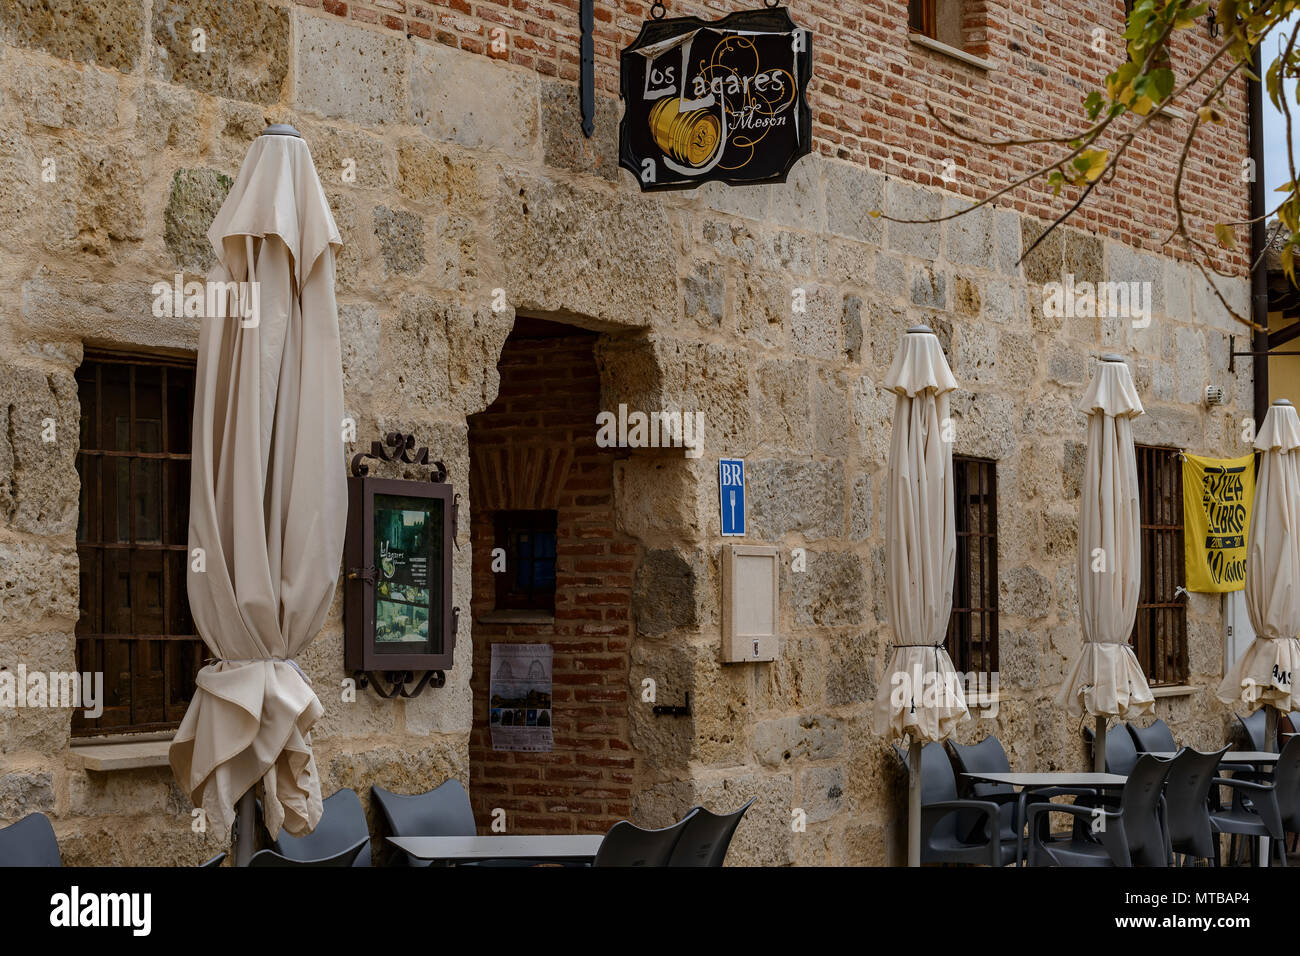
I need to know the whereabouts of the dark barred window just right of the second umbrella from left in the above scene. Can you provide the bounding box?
[945,455,998,674]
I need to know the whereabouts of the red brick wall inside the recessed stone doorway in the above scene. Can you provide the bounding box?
[469,325,637,832]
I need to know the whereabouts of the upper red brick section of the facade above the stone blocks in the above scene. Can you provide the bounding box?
[294,0,1248,273]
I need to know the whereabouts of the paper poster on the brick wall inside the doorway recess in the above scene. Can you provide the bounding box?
[488,644,555,752]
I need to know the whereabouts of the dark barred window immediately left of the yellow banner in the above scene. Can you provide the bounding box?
[1130,445,1188,687]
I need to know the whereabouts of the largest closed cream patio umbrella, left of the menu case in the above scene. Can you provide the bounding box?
[170,126,347,865]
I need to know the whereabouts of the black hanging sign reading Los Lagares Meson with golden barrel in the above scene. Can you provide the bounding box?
[619,7,813,190]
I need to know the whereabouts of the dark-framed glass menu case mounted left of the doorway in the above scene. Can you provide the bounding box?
[343,476,456,672]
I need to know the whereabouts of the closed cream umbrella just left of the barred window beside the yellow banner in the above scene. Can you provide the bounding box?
[1057,355,1156,773]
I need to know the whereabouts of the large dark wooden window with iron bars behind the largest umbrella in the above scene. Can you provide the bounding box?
[73,352,204,736]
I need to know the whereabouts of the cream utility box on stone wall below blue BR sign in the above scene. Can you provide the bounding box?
[723,545,781,663]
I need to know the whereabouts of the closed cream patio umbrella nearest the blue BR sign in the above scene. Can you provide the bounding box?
[875,325,969,866]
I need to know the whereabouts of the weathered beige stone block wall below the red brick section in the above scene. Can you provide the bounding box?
[0,0,1251,864]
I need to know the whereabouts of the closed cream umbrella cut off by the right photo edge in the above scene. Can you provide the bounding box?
[1218,398,1300,749]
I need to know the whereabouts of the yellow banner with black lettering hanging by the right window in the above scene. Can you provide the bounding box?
[1183,455,1255,592]
